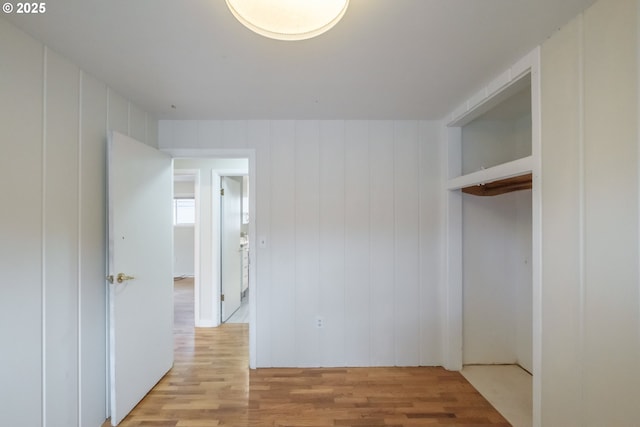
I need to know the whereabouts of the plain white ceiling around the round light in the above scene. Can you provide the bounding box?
[5,0,593,119]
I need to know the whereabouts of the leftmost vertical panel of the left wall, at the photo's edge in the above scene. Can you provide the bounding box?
[0,19,43,427]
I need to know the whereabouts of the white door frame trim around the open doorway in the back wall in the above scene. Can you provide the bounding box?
[160,148,259,369]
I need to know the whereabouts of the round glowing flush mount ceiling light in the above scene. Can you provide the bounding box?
[226,0,349,40]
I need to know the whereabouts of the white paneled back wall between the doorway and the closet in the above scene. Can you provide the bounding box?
[159,120,443,367]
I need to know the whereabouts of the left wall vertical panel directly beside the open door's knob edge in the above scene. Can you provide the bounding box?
[80,74,107,426]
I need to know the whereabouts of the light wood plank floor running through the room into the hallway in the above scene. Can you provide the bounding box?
[105,281,509,427]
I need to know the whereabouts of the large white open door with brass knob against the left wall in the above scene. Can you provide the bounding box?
[108,132,173,426]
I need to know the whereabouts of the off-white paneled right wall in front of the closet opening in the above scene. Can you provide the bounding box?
[541,0,640,426]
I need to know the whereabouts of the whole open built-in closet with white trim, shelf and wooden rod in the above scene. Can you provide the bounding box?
[446,52,540,421]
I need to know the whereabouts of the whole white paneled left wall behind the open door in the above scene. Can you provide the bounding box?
[0,19,157,427]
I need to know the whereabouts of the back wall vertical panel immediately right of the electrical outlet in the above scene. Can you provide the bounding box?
[319,121,345,366]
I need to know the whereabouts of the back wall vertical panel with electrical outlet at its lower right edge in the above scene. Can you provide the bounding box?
[293,121,320,366]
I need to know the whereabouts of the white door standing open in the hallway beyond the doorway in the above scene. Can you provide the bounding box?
[220,177,242,322]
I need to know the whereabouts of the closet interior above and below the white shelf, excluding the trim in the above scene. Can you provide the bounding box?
[461,77,533,372]
